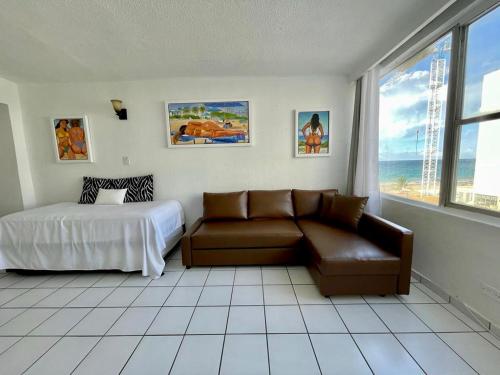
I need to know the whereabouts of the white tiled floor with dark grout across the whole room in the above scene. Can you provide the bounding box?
[0,251,500,375]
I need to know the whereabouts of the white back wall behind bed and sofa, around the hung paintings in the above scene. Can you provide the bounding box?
[20,77,352,222]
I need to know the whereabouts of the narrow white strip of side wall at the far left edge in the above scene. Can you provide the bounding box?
[0,77,35,208]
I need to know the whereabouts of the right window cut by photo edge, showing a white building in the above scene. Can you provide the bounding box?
[451,8,500,212]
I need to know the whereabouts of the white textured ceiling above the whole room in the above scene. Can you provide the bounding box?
[0,0,449,82]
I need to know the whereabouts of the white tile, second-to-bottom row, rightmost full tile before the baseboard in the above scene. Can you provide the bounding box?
[407,304,471,332]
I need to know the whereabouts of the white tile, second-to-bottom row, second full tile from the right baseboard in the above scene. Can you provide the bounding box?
[372,304,431,332]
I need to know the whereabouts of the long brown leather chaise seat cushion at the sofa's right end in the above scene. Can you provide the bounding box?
[297,219,400,275]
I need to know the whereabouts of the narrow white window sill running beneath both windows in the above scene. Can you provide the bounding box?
[380,193,500,228]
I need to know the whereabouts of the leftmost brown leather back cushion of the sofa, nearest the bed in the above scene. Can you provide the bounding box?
[203,191,248,220]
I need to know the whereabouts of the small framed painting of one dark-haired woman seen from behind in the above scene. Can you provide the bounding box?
[295,110,332,158]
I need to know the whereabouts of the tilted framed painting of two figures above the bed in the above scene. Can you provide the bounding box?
[50,115,94,163]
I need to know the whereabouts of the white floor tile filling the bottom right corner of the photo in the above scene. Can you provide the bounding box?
[439,333,500,375]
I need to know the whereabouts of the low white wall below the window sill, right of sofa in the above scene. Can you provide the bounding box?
[382,199,500,327]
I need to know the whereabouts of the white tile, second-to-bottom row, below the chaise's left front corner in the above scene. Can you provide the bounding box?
[300,305,347,333]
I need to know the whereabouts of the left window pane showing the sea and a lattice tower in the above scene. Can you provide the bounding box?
[379,33,451,205]
